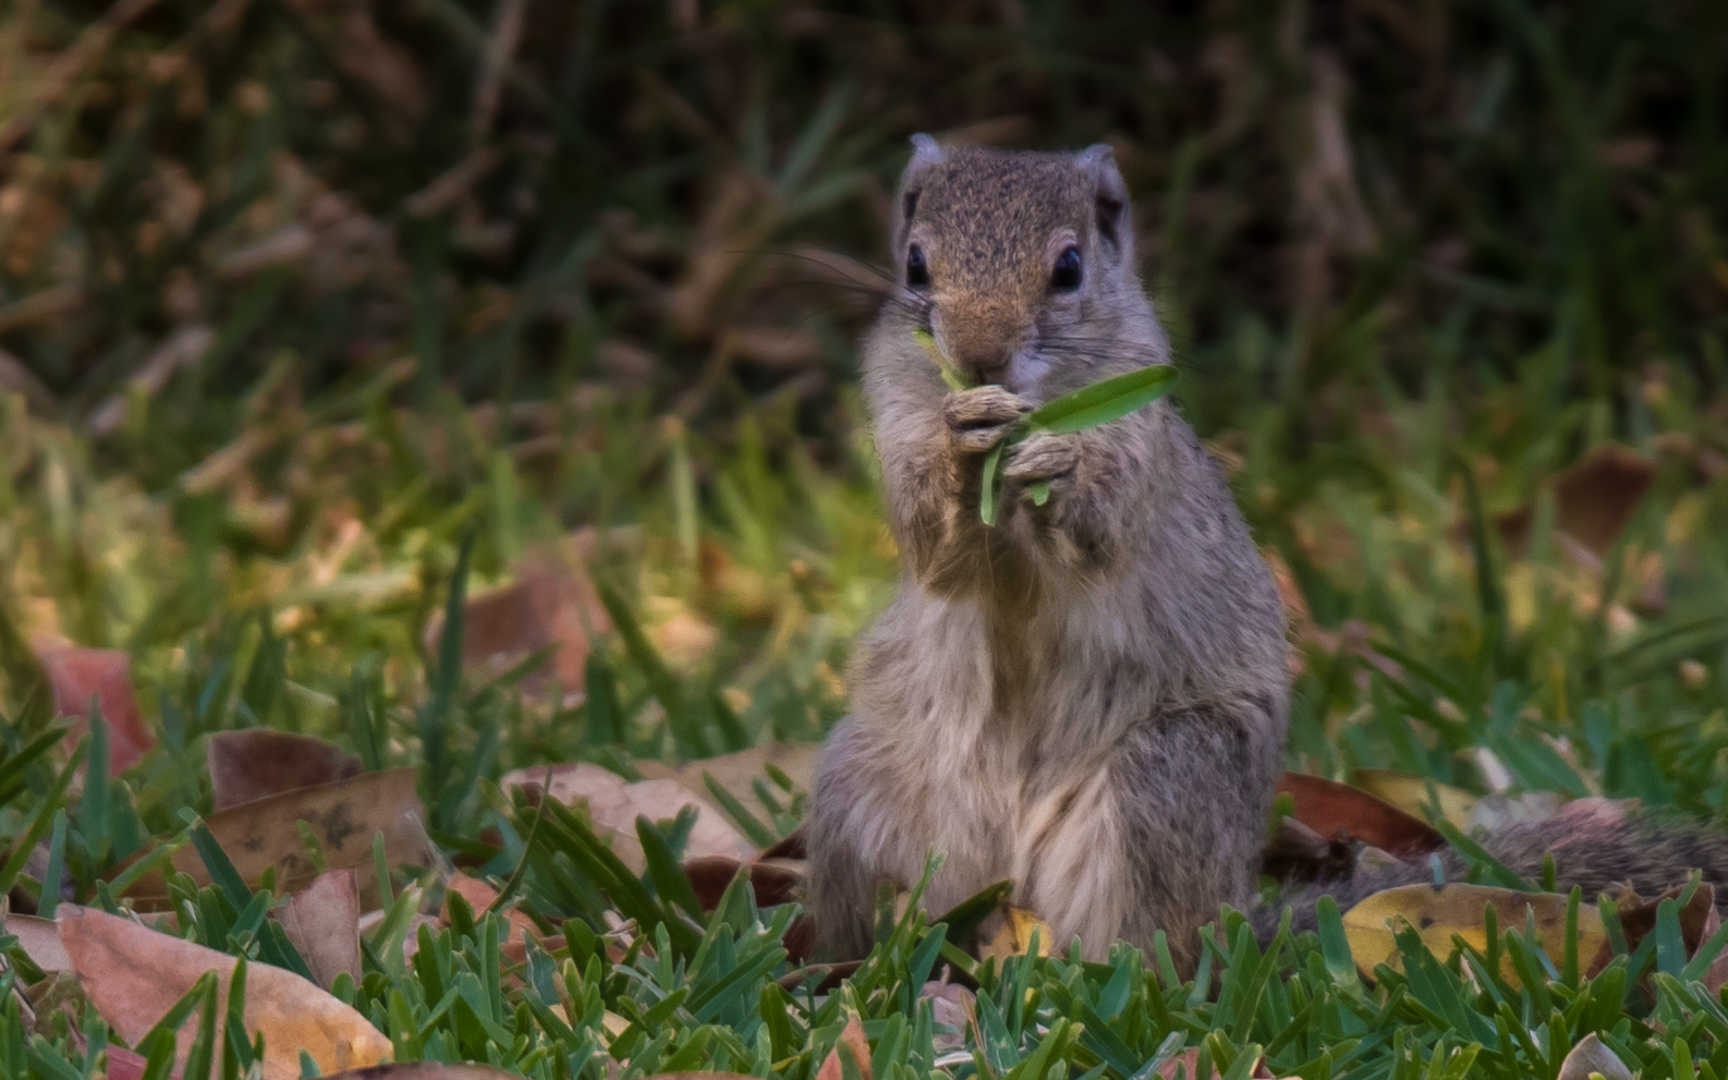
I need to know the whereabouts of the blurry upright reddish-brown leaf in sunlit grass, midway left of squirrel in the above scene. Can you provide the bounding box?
[427,558,612,700]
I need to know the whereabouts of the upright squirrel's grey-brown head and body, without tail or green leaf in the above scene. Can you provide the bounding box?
[809,137,1289,964]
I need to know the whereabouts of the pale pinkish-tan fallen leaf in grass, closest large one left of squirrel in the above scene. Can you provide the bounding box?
[499,762,755,873]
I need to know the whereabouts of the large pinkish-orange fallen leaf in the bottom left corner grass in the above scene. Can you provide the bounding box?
[60,907,391,1080]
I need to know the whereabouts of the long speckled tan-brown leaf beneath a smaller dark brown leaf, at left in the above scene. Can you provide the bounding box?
[128,769,432,909]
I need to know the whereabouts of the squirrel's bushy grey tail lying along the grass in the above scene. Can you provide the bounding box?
[1253,798,1728,943]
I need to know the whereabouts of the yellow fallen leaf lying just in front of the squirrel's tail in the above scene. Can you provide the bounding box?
[1344,885,1610,980]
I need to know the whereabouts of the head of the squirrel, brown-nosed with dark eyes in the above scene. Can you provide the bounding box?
[893,135,1163,394]
